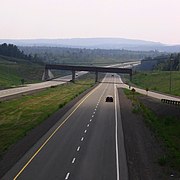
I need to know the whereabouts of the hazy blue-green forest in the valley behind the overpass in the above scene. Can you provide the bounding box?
[20,47,161,66]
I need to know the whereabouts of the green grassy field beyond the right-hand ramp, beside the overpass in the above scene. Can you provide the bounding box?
[129,71,180,96]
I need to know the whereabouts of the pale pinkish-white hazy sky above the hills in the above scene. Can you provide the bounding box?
[0,0,180,44]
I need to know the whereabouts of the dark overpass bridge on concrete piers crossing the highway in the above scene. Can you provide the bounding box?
[44,64,132,82]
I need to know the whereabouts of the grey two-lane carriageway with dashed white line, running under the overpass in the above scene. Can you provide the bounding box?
[2,74,128,180]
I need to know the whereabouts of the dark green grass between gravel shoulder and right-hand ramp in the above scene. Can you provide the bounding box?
[124,90,180,171]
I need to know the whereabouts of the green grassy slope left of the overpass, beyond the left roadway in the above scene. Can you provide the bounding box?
[0,56,44,89]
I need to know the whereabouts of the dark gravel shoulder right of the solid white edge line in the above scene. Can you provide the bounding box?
[118,89,171,180]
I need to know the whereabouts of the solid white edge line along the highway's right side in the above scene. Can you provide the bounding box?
[114,84,119,180]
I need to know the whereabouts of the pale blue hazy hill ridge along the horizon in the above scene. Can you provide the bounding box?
[0,38,180,52]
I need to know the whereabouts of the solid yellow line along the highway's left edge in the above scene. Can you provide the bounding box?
[13,84,102,180]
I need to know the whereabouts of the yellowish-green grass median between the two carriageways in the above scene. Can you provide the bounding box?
[0,75,94,156]
